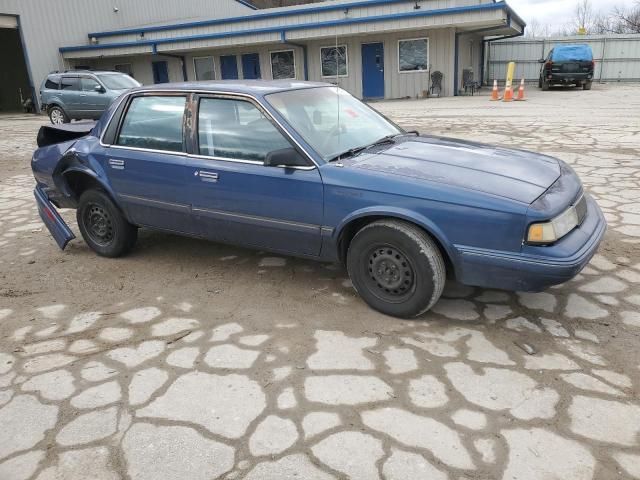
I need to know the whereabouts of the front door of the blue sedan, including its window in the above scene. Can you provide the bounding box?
[187,95,323,256]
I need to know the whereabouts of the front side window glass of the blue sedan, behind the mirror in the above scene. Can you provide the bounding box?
[198,98,291,162]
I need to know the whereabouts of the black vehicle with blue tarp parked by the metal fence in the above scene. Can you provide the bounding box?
[538,44,595,90]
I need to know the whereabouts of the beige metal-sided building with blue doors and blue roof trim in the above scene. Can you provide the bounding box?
[0,0,525,111]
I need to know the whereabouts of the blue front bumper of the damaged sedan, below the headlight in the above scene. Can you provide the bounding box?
[458,195,607,291]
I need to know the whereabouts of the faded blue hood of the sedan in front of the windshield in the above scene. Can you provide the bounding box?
[343,136,560,203]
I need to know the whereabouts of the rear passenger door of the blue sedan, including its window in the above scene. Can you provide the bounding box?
[101,93,194,234]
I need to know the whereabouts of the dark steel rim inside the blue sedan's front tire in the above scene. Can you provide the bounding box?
[367,246,415,302]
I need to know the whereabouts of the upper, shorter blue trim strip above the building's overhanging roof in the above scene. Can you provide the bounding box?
[87,0,432,38]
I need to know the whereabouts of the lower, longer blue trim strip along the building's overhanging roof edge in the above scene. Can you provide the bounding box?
[65,0,508,53]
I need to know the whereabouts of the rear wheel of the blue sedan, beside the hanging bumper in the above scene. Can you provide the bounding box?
[76,190,138,258]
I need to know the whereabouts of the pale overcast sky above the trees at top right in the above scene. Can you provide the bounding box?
[507,0,635,27]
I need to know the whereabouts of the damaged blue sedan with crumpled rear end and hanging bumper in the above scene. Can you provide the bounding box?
[32,81,606,317]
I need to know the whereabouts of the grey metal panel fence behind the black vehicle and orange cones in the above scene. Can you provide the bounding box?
[487,35,640,82]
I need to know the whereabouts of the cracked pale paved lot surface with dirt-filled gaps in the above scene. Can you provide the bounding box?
[0,85,640,480]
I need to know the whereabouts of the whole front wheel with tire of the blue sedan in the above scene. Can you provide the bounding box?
[347,220,446,318]
